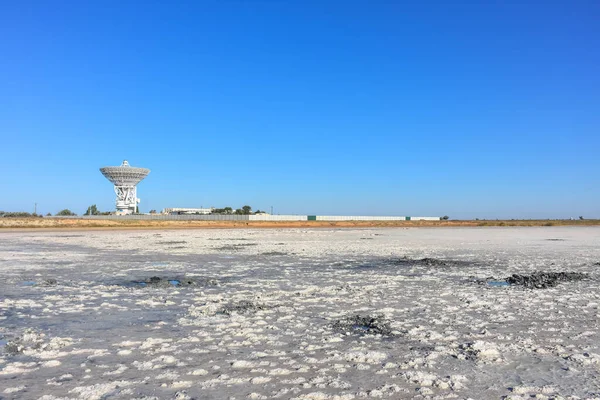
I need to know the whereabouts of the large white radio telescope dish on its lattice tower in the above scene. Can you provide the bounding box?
[100,160,150,215]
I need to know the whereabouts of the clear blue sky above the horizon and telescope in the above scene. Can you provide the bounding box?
[0,0,600,218]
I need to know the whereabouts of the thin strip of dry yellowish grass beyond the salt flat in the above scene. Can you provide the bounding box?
[0,218,600,229]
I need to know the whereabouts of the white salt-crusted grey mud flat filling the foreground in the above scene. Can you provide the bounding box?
[0,227,600,400]
